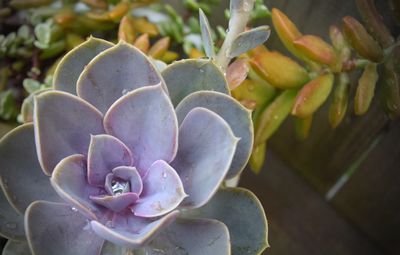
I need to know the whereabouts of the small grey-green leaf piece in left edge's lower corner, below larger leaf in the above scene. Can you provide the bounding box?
[0,189,25,240]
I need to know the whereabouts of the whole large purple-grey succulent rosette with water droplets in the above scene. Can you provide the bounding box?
[0,38,268,255]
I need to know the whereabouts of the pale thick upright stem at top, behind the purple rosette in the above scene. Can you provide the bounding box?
[216,0,255,72]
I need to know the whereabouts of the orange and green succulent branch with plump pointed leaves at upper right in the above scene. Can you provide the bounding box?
[231,0,400,172]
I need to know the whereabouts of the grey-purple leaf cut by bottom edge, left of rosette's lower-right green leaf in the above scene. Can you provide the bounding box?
[146,219,231,255]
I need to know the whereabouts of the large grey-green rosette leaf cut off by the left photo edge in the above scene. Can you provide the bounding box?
[0,124,61,214]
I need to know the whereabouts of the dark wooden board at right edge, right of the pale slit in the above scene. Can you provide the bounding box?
[333,121,400,255]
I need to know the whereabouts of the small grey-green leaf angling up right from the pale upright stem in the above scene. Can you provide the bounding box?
[229,26,271,58]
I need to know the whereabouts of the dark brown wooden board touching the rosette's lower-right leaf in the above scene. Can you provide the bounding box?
[240,152,384,255]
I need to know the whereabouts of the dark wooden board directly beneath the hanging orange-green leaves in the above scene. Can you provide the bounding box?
[269,88,388,194]
